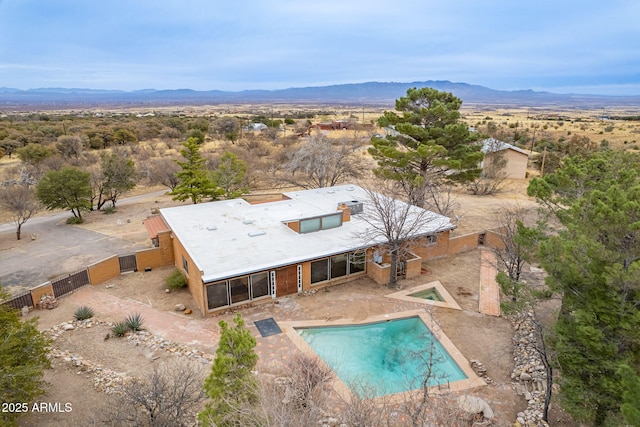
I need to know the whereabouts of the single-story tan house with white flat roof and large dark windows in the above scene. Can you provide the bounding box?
[145,185,455,316]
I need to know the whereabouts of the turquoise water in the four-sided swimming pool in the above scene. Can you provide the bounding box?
[296,317,467,397]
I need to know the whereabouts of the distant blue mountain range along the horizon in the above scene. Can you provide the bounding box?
[0,80,640,111]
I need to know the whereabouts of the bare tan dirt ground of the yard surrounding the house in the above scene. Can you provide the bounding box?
[15,184,572,426]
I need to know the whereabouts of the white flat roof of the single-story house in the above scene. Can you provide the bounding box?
[160,185,454,283]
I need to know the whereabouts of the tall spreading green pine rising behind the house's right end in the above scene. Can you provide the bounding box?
[369,87,483,207]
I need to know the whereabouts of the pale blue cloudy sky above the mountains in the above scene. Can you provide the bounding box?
[0,0,640,95]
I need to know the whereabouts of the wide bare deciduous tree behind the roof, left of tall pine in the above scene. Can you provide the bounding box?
[282,135,367,188]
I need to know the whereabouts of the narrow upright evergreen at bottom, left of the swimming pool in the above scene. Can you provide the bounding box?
[198,313,258,427]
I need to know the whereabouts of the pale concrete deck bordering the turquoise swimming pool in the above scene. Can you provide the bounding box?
[278,310,486,401]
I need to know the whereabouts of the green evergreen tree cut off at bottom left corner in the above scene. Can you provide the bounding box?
[0,287,51,426]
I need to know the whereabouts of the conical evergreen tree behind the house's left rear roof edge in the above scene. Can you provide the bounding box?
[169,138,220,204]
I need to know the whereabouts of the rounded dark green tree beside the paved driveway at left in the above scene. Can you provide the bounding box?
[36,166,92,220]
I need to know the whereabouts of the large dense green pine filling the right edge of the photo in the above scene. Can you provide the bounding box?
[528,151,640,425]
